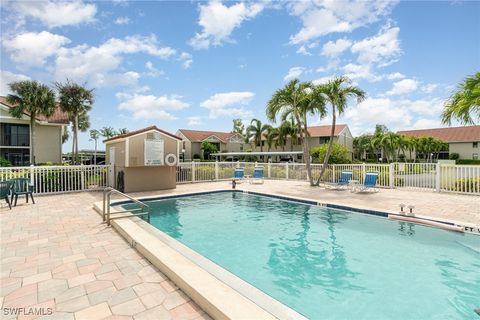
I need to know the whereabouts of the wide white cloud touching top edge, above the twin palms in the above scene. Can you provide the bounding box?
[290,0,397,44]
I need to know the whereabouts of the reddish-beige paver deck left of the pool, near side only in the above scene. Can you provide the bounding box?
[0,192,208,320]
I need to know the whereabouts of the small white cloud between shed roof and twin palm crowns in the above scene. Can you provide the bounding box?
[200,91,255,119]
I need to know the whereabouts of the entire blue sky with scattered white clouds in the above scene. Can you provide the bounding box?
[0,0,480,151]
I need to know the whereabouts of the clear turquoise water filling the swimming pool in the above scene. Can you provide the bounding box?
[123,192,480,319]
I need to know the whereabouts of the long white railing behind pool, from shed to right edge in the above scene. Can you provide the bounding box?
[177,162,480,194]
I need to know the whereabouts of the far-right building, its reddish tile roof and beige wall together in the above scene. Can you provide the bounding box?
[398,126,480,159]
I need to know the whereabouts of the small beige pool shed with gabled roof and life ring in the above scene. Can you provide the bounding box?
[104,126,182,192]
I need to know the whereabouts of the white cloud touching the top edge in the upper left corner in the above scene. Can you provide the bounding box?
[13,0,97,28]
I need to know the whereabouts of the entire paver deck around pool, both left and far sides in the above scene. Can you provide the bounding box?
[0,181,480,320]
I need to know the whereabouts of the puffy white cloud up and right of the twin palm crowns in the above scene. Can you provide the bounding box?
[351,26,401,66]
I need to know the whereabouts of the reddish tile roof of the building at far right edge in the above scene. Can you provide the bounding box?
[397,126,480,142]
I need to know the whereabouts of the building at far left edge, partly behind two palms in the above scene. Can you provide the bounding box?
[0,96,69,166]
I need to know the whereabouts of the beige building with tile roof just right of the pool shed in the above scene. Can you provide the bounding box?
[176,129,249,161]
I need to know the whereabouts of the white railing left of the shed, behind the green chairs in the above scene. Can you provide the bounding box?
[0,165,110,194]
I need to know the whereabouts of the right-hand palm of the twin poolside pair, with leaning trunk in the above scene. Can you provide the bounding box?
[313,77,366,185]
